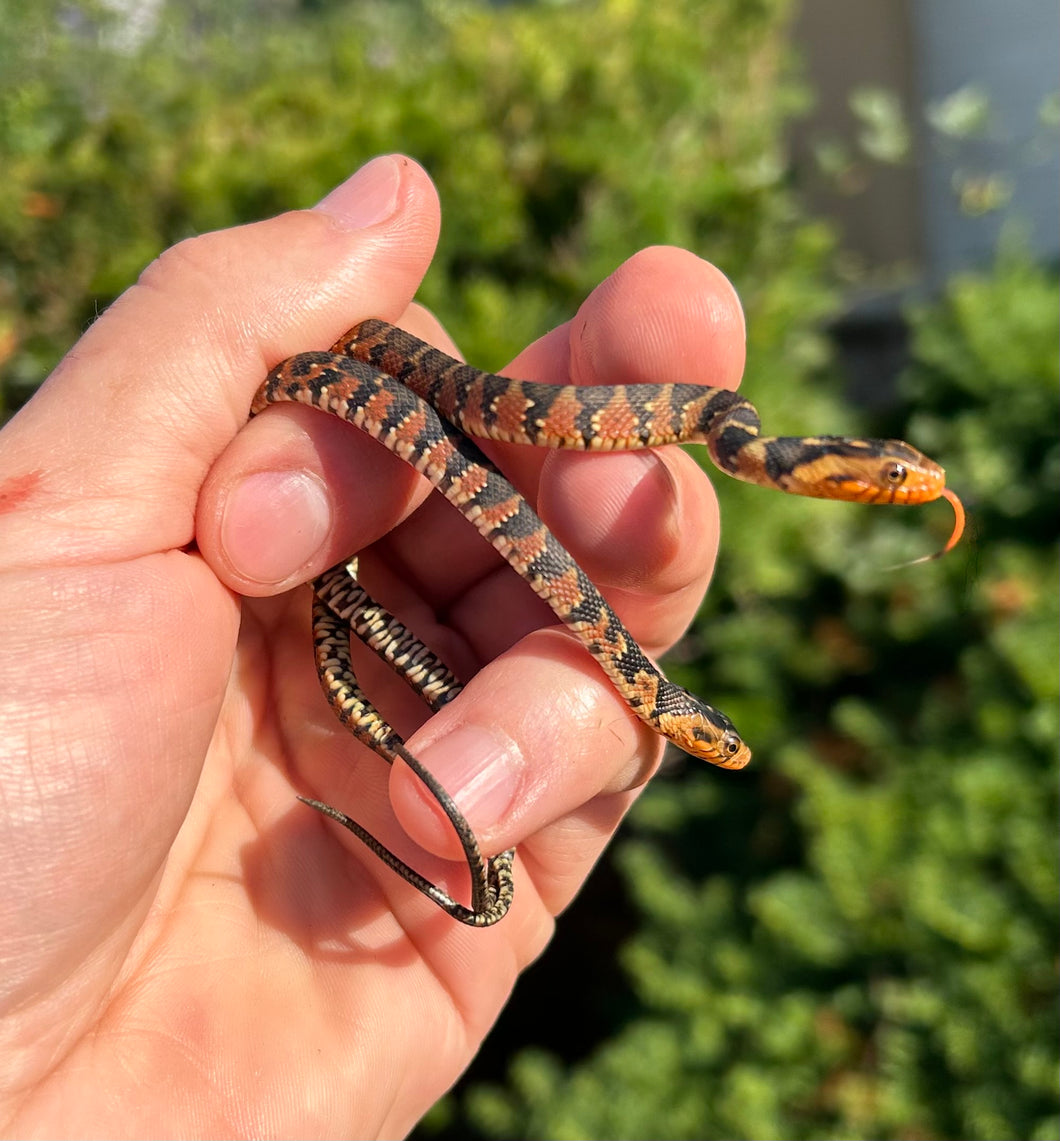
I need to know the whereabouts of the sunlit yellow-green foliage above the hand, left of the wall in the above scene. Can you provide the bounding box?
[0,0,822,399]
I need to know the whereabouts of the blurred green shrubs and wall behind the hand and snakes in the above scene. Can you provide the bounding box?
[0,0,1060,1141]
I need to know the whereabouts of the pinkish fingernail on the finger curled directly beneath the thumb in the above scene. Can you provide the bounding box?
[220,471,331,584]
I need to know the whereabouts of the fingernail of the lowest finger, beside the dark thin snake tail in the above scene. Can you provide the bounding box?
[420,726,525,826]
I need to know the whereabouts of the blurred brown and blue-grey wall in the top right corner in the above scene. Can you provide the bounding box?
[791,0,1060,296]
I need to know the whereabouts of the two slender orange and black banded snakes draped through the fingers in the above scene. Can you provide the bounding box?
[251,319,963,926]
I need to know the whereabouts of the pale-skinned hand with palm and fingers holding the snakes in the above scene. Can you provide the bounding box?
[0,156,744,1138]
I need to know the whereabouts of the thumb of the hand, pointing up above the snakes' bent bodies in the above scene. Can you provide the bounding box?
[0,155,438,565]
